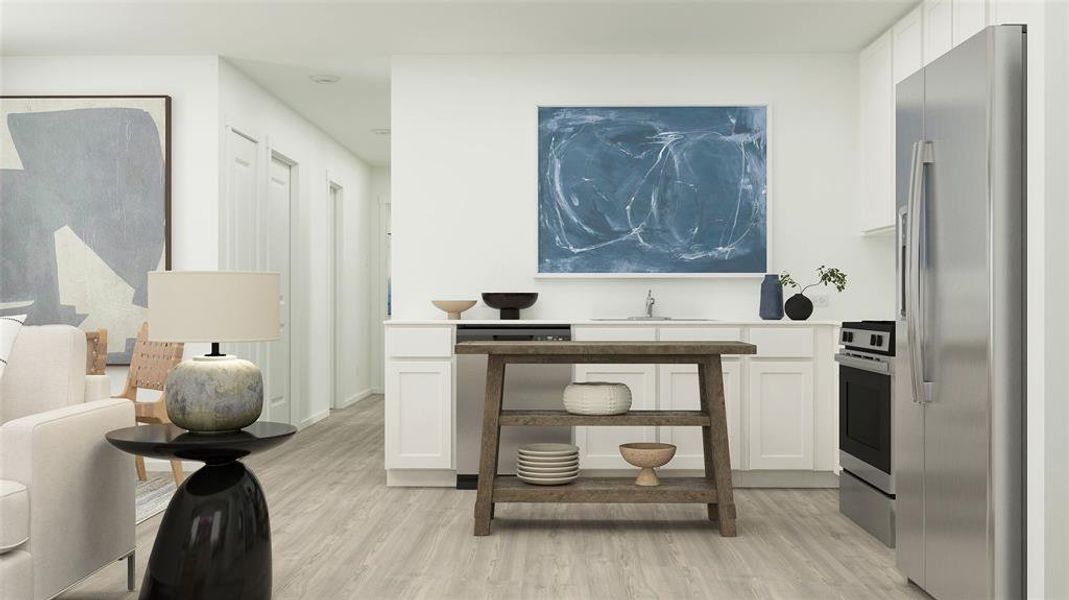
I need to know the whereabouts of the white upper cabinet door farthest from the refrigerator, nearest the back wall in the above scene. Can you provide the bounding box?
[857,32,895,232]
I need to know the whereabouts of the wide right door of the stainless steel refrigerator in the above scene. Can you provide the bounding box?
[920,31,991,598]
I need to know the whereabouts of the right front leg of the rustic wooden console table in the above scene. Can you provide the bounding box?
[698,356,735,537]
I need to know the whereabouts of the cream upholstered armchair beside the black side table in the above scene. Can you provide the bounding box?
[0,325,135,600]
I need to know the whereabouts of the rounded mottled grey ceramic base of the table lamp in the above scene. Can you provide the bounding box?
[165,356,264,432]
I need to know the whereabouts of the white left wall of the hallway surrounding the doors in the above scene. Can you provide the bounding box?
[215,61,372,425]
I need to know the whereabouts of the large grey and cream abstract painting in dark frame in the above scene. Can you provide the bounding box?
[0,96,170,365]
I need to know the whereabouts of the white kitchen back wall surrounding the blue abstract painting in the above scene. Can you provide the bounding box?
[391,55,894,319]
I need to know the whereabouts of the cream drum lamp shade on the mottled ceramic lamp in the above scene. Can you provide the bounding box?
[149,271,279,342]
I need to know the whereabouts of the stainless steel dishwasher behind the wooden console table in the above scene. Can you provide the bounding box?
[456,323,572,489]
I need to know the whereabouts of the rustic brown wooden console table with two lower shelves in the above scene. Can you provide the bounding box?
[456,341,757,537]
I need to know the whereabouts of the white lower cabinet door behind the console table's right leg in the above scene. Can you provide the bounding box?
[657,359,744,470]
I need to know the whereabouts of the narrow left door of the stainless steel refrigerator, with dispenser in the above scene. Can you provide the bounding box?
[892,67,925,585]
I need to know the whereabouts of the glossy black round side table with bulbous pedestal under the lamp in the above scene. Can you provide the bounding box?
[106,422,297,600]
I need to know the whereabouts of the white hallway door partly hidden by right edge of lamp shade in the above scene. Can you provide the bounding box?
[264,155,299,425]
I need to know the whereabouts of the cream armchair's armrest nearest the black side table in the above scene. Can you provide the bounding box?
[0,399,135,598]
